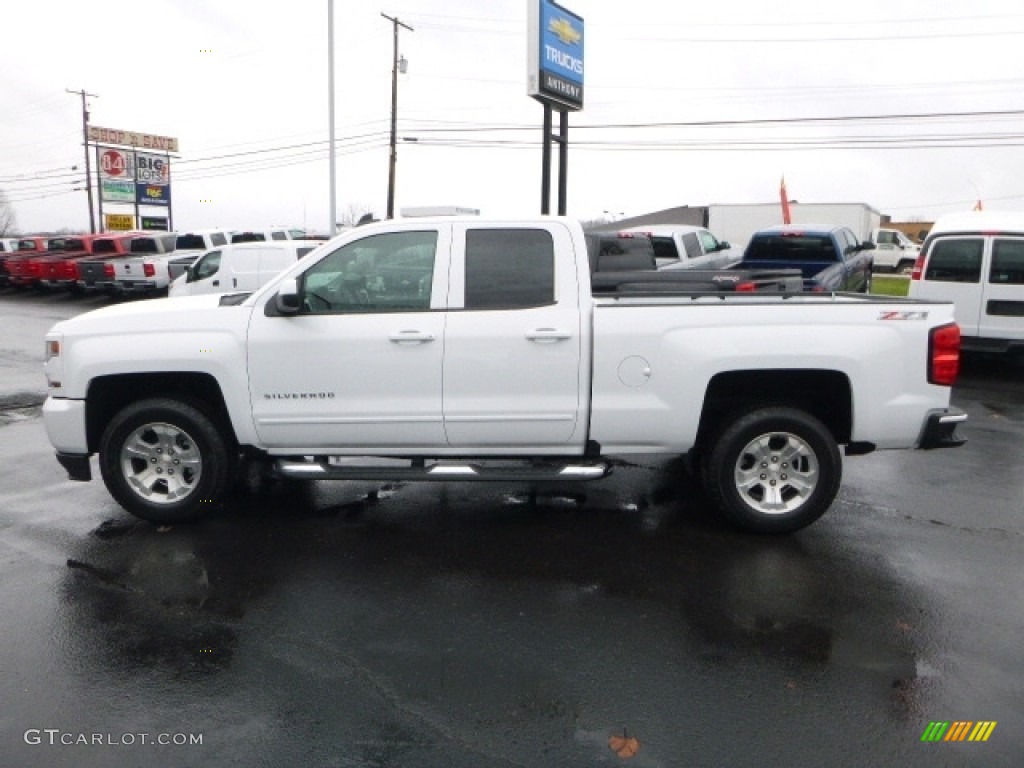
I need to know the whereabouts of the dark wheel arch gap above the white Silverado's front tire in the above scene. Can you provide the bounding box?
[85,372,234,453]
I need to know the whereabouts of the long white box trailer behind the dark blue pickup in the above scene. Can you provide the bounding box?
[708,202,882,248]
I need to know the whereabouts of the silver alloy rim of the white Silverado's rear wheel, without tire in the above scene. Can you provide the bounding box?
[733,432,819,515]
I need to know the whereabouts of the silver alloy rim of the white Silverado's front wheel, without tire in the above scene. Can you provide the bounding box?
[120,422,203,504]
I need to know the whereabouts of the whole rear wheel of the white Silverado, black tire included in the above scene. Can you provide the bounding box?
[702,407,843,534]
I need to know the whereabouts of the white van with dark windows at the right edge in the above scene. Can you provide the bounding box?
[909,211,1024,352]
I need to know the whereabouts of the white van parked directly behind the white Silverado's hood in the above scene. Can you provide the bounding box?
[167,240,324,296]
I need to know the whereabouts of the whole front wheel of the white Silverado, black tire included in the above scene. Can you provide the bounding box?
[99,397,232,524]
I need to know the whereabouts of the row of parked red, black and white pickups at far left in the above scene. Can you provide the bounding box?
[0,228,322,296]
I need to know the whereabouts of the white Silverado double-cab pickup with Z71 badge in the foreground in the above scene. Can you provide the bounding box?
[43,217,967,532]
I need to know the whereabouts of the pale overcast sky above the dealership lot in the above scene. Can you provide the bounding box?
[0,0,1024,232]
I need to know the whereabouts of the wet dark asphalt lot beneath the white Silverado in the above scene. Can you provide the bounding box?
[0,290,1024,767]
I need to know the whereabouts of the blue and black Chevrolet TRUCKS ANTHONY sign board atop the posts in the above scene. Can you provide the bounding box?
[526,0,584,110]
